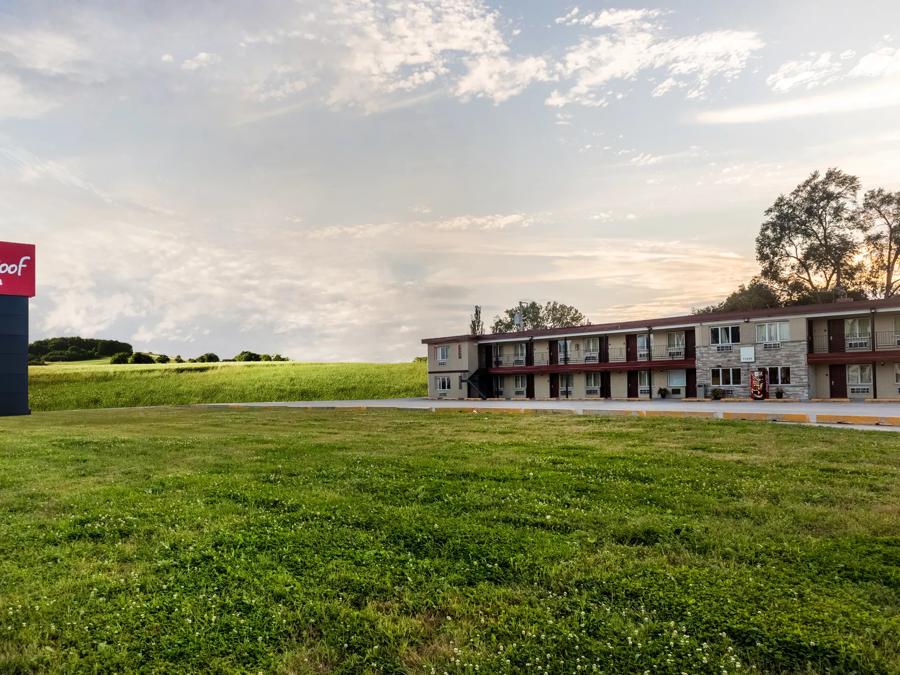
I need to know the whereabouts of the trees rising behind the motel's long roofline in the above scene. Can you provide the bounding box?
[469,168,900,335]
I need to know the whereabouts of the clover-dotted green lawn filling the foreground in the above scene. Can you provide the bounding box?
[0,409,900,673]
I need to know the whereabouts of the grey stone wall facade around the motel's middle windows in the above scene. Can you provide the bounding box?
[697,340,809,400]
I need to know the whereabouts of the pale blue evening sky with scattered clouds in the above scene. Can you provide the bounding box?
[0,0,900,361]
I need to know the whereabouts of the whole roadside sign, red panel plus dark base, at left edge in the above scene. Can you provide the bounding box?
[0,241,36,416]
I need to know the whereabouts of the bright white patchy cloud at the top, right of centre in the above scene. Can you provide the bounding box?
[546,9,764,107]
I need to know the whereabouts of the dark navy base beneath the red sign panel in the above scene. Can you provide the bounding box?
[0,295,31,416]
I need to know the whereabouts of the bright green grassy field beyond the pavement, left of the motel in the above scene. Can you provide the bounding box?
[28,361,427,411]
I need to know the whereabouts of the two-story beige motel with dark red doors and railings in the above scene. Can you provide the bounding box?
[422,298,900,400]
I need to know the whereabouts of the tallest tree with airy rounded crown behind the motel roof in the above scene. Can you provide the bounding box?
[756,169,864,302]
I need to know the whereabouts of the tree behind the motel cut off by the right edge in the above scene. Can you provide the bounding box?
[859,188,900,298]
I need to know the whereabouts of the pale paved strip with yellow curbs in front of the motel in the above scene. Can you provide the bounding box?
[211,398,900,431]
